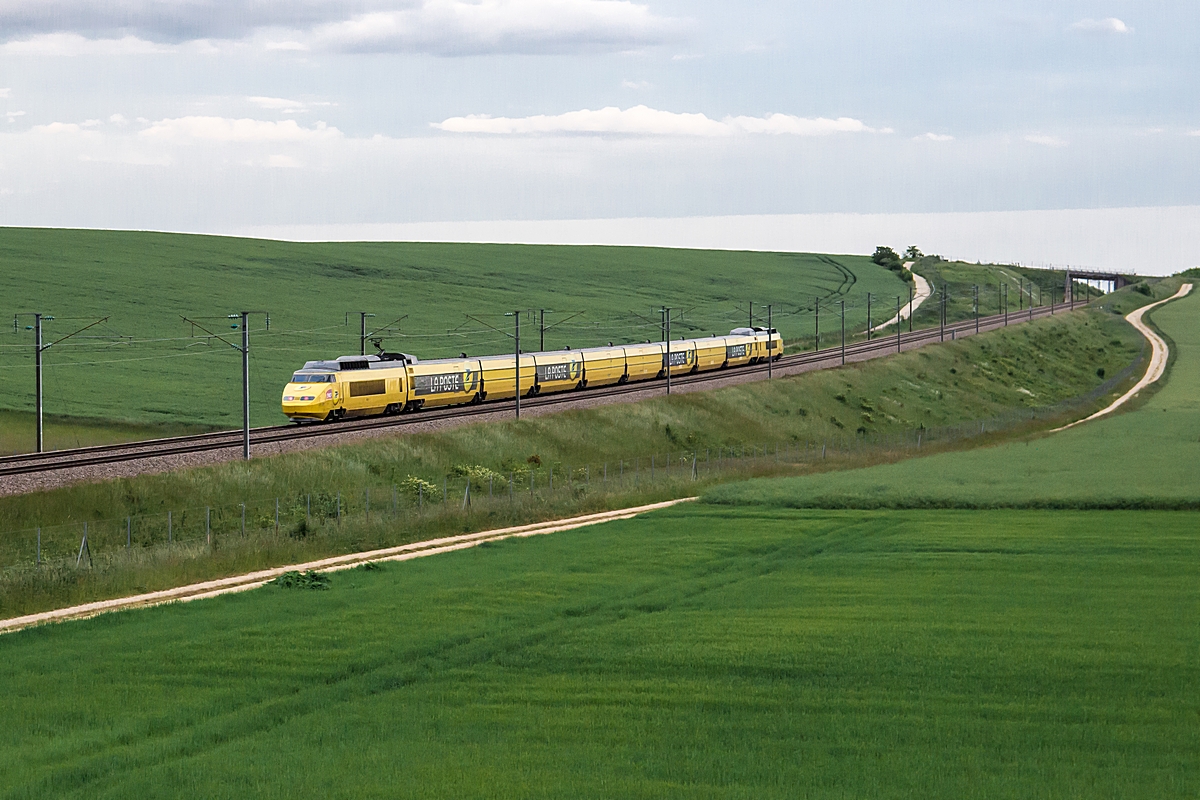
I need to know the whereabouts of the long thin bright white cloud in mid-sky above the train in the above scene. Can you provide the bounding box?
[432,106,892,137]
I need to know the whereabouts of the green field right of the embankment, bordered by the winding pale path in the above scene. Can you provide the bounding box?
[707,281,1200,507]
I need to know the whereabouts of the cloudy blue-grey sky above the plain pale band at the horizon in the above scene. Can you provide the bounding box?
[0,0,1200,268]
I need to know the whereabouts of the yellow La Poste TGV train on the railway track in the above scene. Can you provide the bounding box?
[283,327,784,422]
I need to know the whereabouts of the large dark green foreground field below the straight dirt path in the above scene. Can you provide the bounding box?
[0,506,1200,800]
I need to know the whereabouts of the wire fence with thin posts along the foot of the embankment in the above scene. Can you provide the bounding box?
[0,359,1141,573]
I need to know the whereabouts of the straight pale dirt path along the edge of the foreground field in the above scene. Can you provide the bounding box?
[0,498,696,634]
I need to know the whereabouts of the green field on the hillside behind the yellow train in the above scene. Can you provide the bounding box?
[0,228,907,438]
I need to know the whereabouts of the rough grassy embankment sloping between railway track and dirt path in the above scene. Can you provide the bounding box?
[0,296,1141,616]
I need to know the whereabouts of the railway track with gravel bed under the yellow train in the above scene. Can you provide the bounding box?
[0,299,1066,476]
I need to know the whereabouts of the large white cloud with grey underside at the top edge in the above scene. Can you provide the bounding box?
[311,0,683,55]
